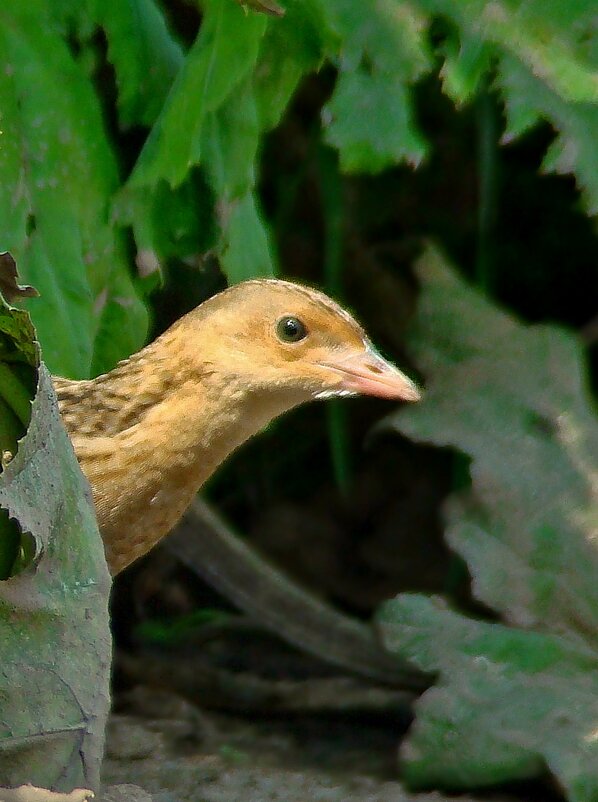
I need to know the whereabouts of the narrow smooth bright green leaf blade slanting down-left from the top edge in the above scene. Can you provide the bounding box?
[129,0,267,187]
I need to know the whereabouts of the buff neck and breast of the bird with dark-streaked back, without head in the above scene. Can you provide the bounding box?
[57,330,304,573]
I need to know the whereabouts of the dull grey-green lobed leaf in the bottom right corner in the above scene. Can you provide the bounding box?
[379,594,598,802]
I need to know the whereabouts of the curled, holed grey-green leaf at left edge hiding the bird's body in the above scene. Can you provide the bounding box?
[0,260,110,792]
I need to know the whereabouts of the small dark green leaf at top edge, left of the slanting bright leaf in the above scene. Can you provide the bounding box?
[89,0,183,126]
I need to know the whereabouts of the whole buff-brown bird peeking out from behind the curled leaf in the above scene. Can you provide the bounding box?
[53,279,420,575]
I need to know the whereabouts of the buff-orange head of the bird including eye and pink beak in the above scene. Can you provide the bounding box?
[191,279,420,403]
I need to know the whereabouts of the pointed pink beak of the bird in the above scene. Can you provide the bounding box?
[321,348,421,401]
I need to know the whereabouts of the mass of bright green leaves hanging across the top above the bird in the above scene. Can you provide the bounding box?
[0,0,598,376]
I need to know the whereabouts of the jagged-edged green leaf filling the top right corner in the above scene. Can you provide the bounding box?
[417,0,598,214]
